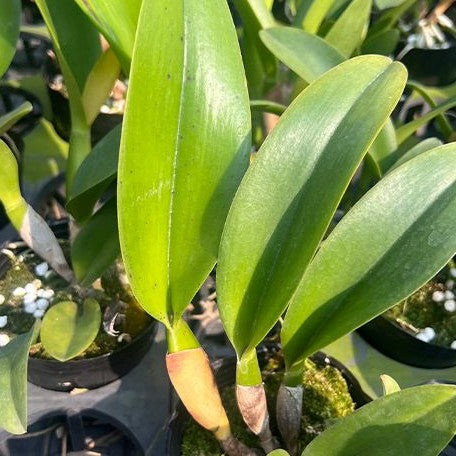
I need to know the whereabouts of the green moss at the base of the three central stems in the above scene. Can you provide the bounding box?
[182,353,355,456]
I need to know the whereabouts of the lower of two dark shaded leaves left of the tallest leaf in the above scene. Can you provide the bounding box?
[71,198,120,287]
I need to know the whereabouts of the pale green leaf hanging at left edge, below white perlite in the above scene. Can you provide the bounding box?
[0,321,39,434]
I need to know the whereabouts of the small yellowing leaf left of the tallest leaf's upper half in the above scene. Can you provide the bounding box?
[82,49,120,124]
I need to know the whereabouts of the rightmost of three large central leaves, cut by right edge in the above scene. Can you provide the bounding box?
[282,144,456,366]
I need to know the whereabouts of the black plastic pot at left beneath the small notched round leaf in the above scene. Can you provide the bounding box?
[0,228,158,391]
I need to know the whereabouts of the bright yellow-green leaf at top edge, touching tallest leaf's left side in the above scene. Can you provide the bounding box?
[75,0,142,74]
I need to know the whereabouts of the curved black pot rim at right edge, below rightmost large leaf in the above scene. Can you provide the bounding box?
[357,316,456,369]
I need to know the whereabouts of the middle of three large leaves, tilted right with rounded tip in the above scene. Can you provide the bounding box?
[217,56,406,355]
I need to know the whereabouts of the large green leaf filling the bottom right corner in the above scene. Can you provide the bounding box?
[302,385,456,456]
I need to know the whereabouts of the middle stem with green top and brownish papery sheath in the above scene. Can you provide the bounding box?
[236,350,278,453]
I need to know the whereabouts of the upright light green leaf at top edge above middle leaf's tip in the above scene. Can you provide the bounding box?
[325,0,372,57]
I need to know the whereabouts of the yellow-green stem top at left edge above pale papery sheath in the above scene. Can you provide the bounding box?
[0,139,27,226]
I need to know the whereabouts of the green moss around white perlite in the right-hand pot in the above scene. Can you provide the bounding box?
[385,261,456,347]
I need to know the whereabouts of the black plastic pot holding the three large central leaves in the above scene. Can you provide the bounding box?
[166,352,372,456]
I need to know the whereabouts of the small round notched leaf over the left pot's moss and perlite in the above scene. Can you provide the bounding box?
[40,298,101,361]
